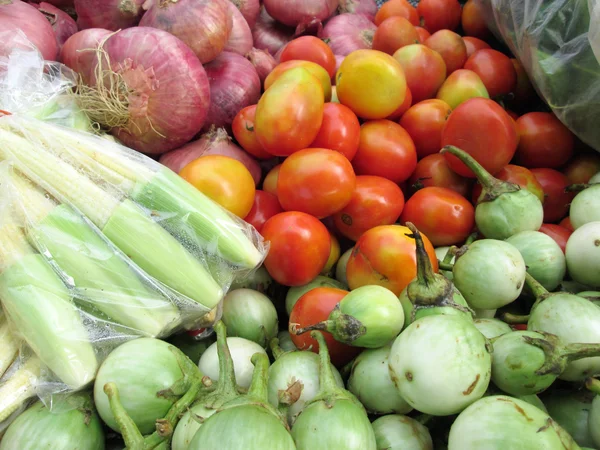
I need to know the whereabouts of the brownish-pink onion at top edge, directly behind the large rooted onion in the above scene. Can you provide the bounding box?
[140,0,233,64]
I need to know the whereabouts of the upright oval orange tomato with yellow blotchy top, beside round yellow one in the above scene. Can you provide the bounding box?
[254,67,325,156]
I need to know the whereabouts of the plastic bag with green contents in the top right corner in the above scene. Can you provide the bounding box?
[476,0,600,151]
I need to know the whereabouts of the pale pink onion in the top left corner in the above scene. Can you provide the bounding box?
[0,0,58,61]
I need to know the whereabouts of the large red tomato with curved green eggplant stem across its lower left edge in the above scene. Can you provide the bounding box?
[442,97,518,178]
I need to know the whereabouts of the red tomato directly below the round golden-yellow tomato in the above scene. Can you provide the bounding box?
[352,119,417,183]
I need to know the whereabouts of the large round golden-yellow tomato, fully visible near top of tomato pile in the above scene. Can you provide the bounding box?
[336,50,406,119]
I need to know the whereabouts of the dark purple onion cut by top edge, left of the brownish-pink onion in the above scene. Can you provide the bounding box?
[75,0,144,31]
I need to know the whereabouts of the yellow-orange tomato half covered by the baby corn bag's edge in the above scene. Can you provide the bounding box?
[179,155,256,218]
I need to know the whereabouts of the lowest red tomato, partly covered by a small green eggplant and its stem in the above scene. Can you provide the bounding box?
[289,287,361,368]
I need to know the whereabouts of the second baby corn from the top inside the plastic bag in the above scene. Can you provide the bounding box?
[0,126,223,311]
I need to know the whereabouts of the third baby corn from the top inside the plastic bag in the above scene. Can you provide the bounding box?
[10,171,179,337]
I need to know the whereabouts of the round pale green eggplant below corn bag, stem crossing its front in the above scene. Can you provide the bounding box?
[94,338,189,434]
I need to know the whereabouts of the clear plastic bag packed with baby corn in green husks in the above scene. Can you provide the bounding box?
[0,44,268,404]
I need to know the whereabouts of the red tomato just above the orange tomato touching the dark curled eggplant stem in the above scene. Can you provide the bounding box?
[333,175,404,241]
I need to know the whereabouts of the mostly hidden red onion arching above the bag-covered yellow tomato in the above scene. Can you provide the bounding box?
[158,128,261,184]
